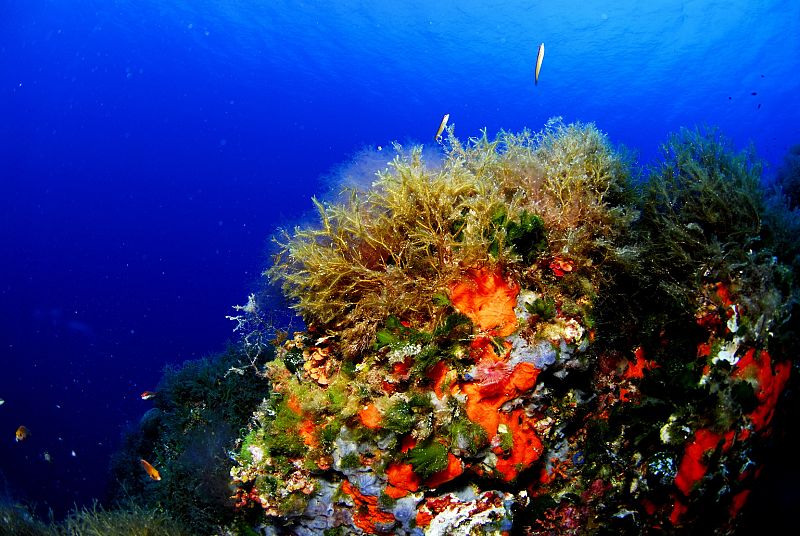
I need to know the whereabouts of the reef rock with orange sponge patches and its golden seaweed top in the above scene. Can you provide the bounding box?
[231,122,797,535]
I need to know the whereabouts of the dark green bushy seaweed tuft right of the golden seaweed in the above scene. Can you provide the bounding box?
[642,128,764,308]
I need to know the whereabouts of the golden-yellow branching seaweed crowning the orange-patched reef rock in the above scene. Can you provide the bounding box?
[267,119,631,354]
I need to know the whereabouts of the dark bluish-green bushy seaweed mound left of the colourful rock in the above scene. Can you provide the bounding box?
[106,346,273,534]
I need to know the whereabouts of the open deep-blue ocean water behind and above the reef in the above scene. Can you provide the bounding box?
[0,0,800,513]
